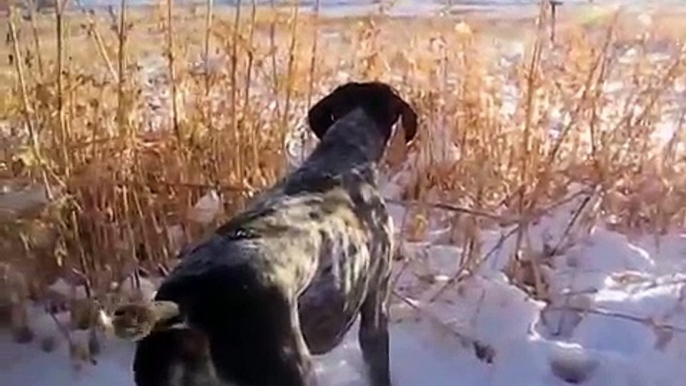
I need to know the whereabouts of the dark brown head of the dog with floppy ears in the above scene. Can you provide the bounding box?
[307,82,417,143]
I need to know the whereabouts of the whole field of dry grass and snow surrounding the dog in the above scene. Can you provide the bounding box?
[0,2,686,386]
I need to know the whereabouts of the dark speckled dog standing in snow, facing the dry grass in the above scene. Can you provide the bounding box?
[134,83,417,386]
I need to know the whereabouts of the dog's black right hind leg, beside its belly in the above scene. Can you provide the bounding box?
[203,286,317,386]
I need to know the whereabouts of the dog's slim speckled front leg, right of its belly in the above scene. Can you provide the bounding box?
[358,277,391,386]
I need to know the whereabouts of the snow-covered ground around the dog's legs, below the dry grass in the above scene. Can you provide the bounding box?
[0,179,686,386]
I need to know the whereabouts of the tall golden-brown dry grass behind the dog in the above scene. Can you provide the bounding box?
[0,0,686,364]
